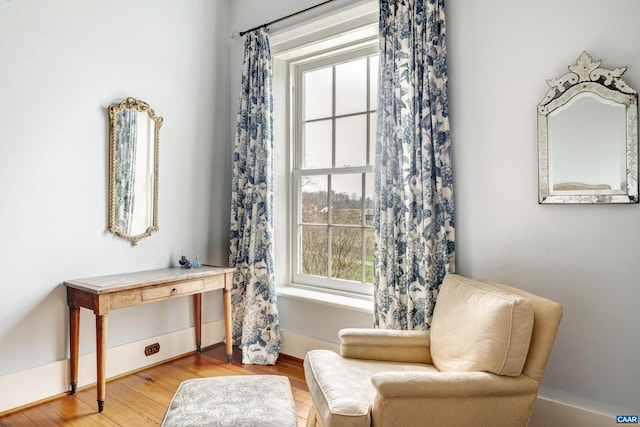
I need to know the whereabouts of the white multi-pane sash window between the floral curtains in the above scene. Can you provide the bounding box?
[291,46,378,294]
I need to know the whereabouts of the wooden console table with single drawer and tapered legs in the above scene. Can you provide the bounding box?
[64,266,235,412]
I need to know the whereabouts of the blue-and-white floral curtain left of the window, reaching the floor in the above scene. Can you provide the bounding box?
[229,28,281,365]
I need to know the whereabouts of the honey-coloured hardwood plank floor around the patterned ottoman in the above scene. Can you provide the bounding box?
[0,344,311,427]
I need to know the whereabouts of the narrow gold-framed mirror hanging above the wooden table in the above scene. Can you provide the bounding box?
[109,98,162,245]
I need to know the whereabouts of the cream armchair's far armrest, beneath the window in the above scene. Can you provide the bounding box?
[339,328,432,364]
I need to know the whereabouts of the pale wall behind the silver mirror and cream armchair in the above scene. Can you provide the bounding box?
[446,0,640,414]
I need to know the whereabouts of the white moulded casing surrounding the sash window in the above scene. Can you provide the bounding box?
[271,0,378,299]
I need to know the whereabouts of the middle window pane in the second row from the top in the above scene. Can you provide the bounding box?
[336,114,367,168]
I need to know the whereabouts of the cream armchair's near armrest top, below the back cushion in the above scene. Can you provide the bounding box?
[371,372,539,399]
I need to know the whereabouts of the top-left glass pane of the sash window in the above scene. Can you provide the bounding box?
[304,67,333,120]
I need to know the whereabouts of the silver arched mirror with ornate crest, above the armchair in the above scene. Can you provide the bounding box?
[538,52,638,203]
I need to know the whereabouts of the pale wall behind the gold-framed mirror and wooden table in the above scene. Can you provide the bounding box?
[0,0,231,396]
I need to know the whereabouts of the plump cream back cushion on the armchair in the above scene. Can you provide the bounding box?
[431,274,533,376]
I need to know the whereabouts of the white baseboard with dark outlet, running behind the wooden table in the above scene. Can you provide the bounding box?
[0,320,224,414]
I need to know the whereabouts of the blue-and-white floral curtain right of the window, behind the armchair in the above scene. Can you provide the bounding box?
[374,0,455,330]
